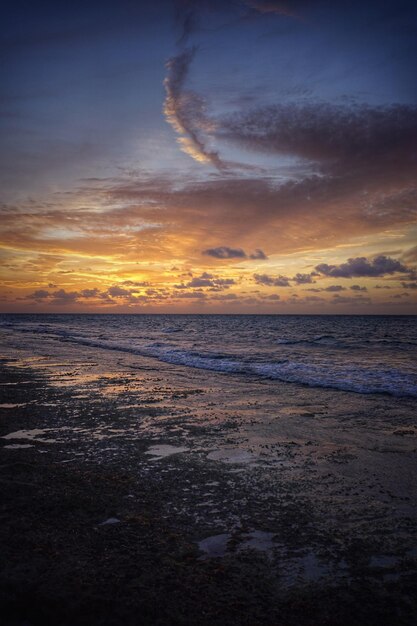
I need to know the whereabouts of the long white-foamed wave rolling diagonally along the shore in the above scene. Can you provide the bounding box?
[3,324,417,397]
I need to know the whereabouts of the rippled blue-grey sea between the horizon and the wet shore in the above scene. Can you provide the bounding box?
[0,315,417,397]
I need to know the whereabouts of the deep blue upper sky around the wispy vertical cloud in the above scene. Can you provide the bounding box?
[1,0,417,191]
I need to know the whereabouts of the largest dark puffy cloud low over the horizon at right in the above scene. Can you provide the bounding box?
[316,255,410,278]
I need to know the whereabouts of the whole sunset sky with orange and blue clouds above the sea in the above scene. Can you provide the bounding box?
[0,0,417,314]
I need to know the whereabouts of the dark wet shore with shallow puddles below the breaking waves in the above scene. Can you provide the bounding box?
[0,337,417,626]
